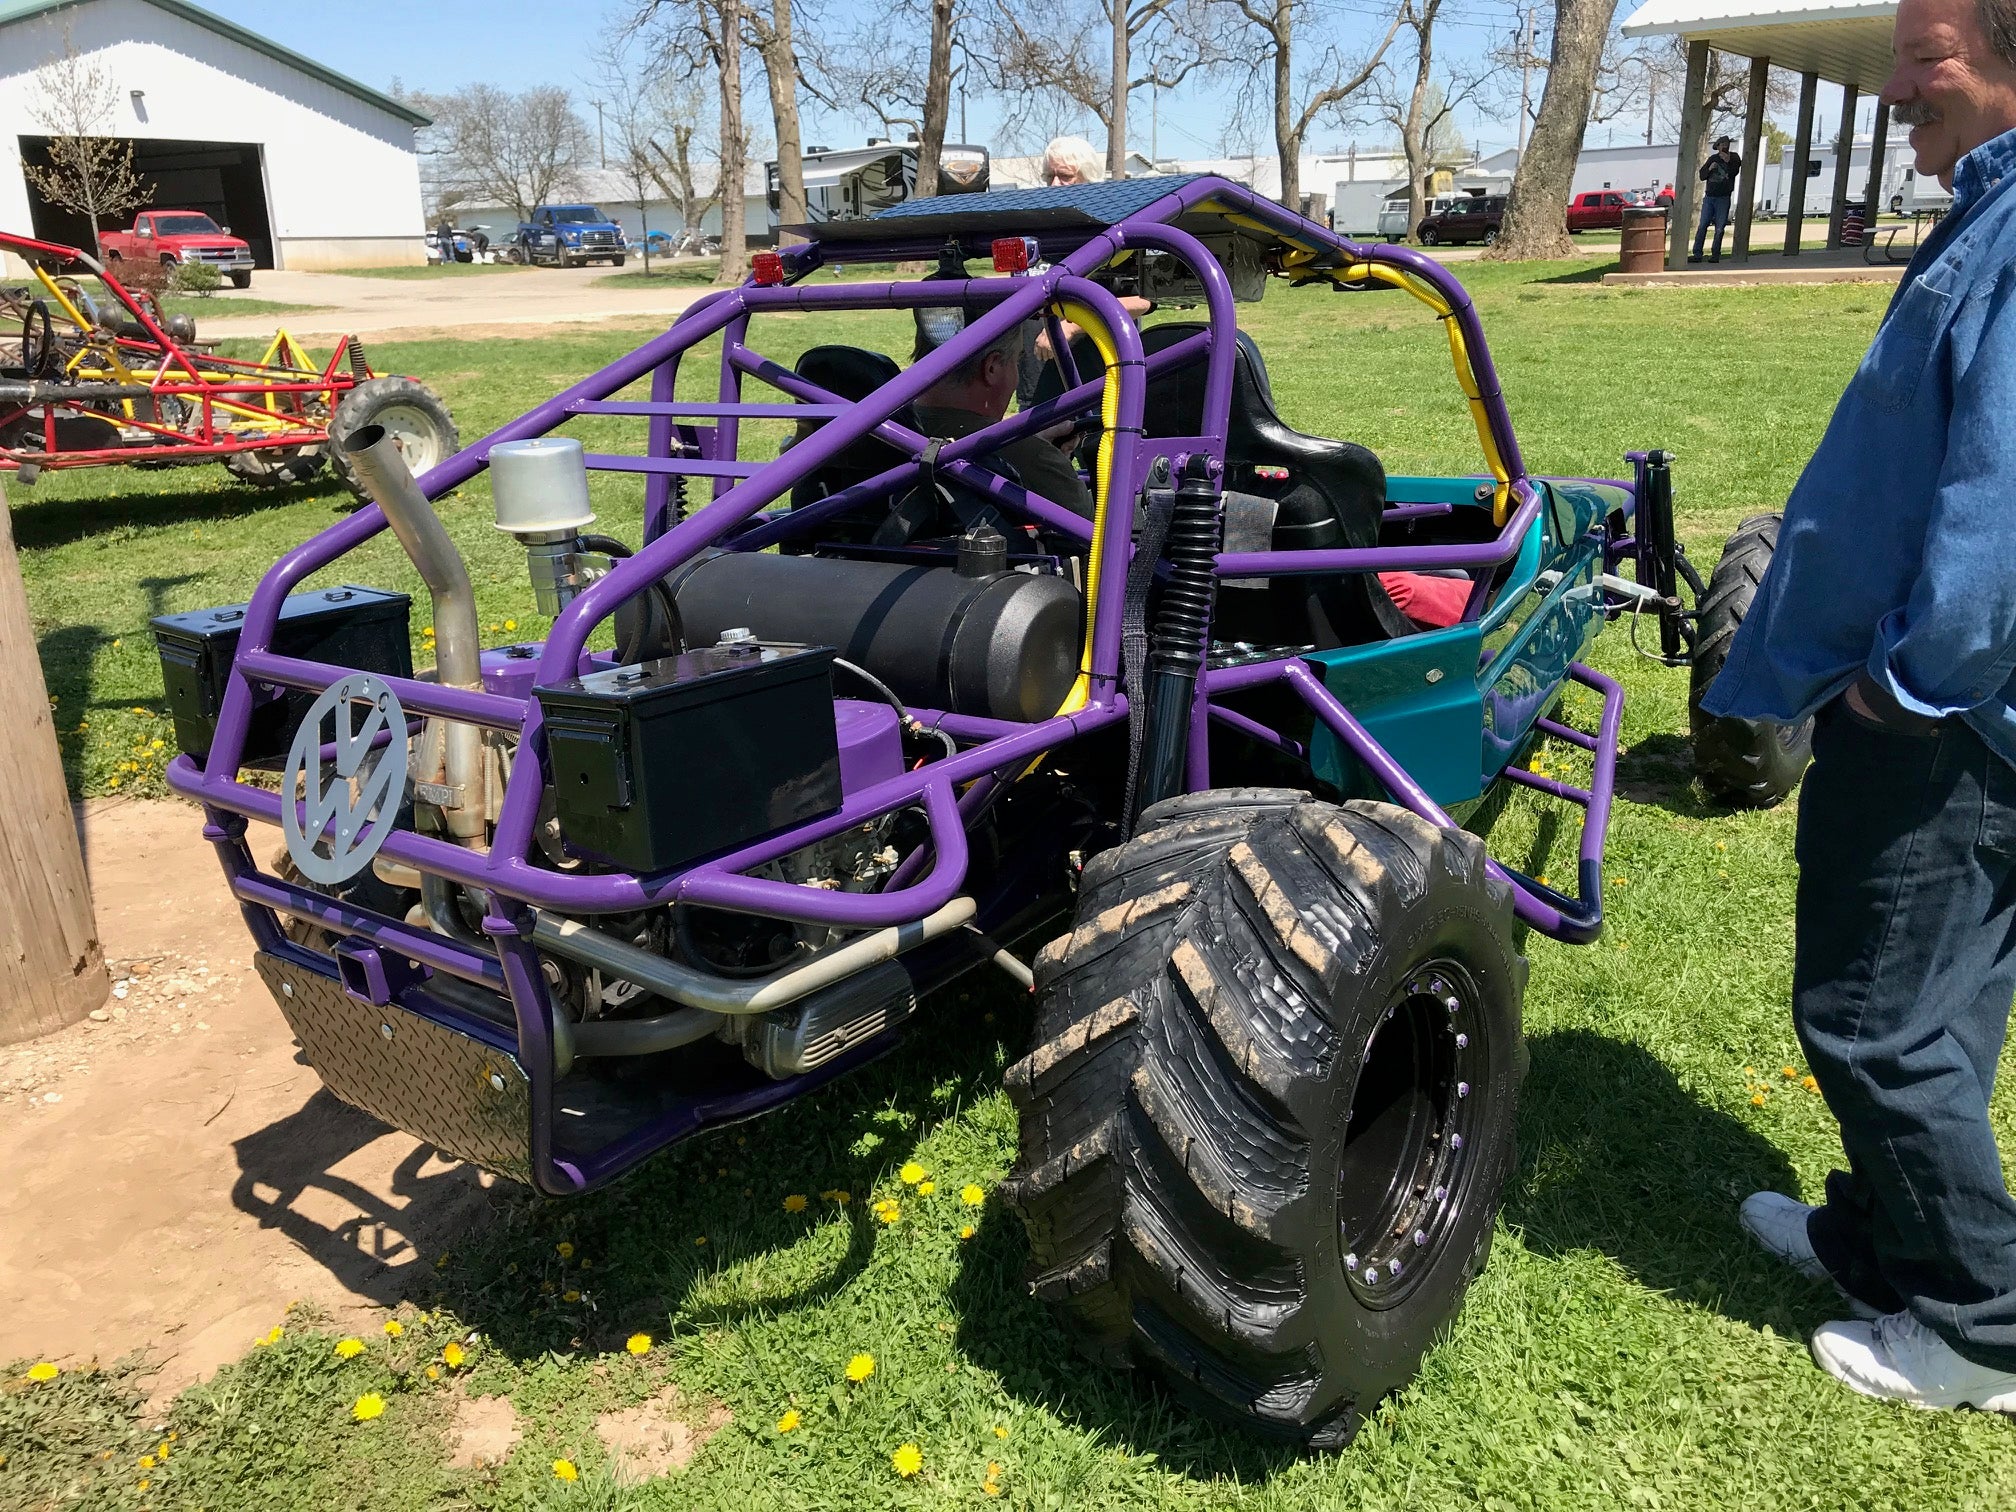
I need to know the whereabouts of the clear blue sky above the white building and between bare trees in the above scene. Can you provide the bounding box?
[200,0,1867,157]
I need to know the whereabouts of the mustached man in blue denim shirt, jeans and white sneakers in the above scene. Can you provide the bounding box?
[1704,0,2016,1413]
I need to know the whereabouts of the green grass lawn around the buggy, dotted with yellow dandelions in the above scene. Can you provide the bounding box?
[0,264,2016,1512]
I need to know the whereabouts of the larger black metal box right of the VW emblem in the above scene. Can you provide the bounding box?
[534,641,841,871]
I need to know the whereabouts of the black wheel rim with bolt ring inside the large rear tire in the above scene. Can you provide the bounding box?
[1337,960,1488,1306]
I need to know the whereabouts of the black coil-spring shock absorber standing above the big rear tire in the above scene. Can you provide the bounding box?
[1141,456,1224,808]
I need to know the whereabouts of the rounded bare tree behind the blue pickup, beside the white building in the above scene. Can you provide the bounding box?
[401,85,589,220]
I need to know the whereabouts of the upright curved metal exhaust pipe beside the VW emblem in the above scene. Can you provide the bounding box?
[341,425,490,845]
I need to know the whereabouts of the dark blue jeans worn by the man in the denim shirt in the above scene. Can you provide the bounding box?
[1792,698,2016,1371]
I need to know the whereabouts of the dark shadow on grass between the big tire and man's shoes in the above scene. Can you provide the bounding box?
[1504,1030,1804,1331]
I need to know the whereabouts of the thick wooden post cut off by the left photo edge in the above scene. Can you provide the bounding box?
[0,479,109,1044]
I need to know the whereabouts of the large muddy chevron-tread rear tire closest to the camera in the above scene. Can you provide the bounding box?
[1006,788,1526,1450]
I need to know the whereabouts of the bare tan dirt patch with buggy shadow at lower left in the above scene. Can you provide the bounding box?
[0,798,492,1395]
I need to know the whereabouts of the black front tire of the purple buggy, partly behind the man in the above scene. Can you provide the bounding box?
[1687,514,1812,808]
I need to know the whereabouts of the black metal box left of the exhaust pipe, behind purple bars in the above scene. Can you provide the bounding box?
[153,585,413,766]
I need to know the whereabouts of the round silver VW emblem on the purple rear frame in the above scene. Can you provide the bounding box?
[280,671,405,883]
